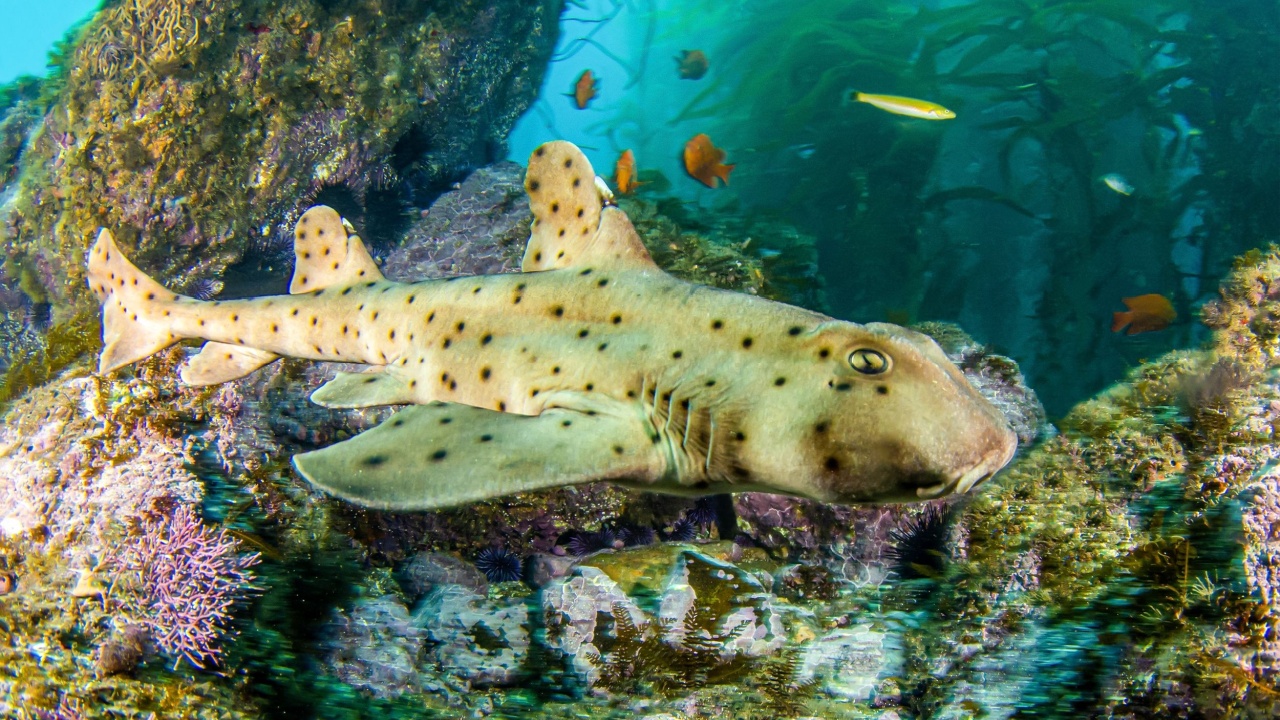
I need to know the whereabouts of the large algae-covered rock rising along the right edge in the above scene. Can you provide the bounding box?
[890,247,1280,717]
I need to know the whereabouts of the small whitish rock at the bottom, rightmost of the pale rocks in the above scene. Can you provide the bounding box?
[795,624,902,702]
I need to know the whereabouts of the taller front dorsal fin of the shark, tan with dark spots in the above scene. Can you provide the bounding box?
[521,141,658,273]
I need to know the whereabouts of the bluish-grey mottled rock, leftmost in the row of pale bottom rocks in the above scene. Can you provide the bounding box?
[320,594,428,698]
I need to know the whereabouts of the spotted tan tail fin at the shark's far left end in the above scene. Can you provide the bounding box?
[88,228,180,373]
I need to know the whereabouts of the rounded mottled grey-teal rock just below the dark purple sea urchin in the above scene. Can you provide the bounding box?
[413,585,530,688]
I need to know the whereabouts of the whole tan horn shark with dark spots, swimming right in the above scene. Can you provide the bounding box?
[88,142,1016,510]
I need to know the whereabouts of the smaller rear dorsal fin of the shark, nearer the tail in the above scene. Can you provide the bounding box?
[289,205,383,293]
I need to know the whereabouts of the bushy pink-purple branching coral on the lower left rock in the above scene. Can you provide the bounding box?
[108,506,259,669]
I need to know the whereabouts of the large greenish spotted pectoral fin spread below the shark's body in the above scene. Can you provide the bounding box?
[293,404,667,510]
